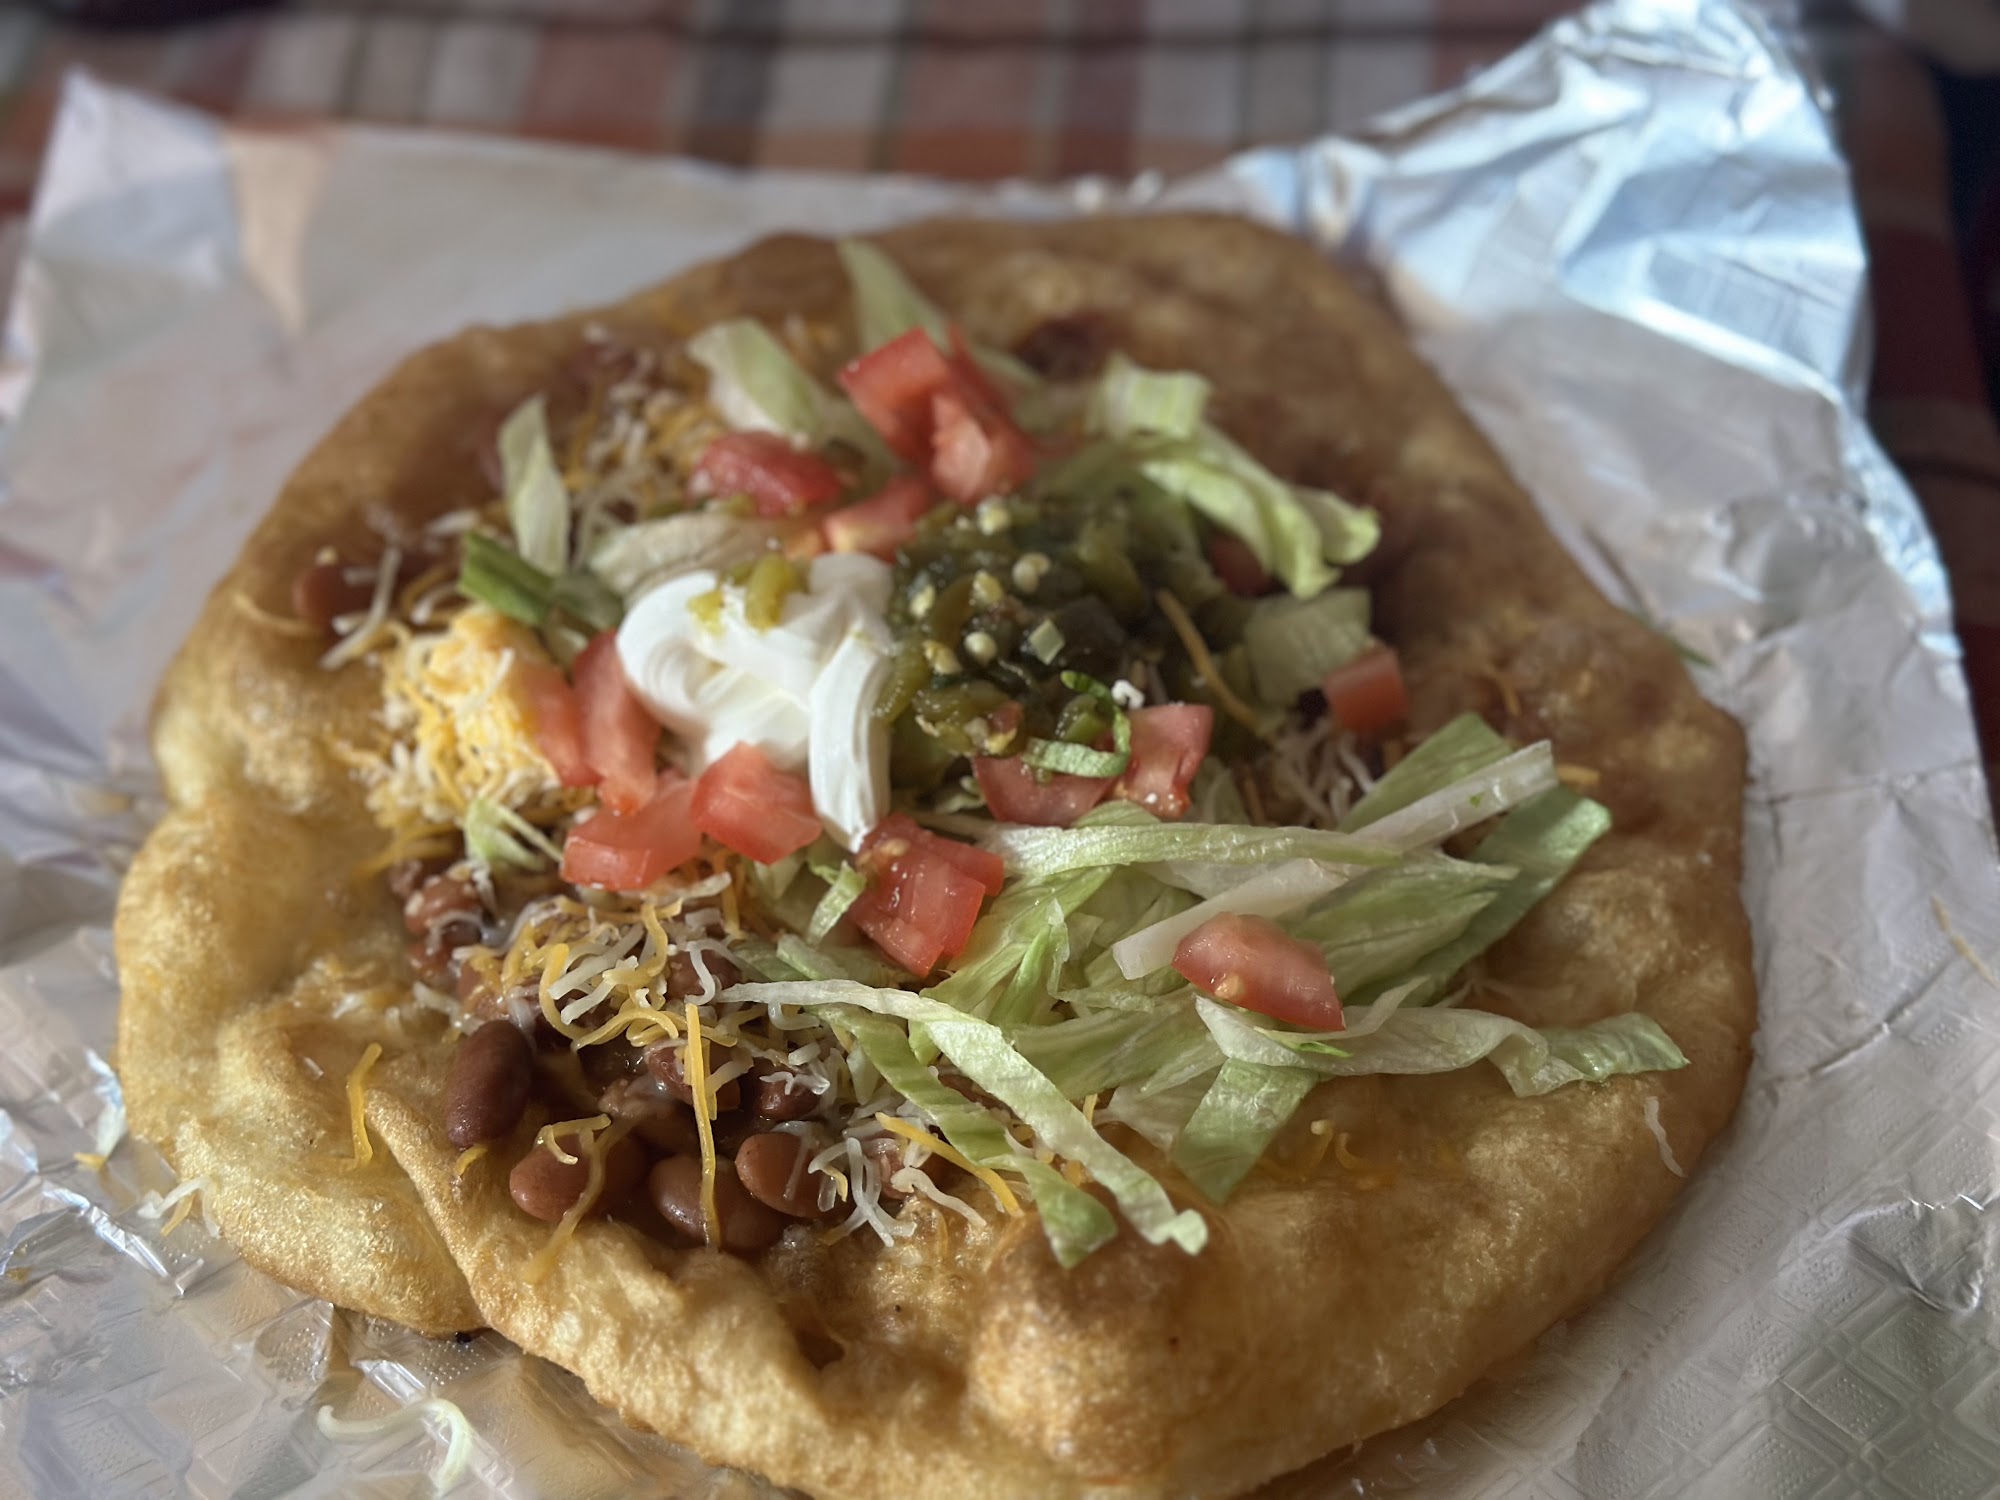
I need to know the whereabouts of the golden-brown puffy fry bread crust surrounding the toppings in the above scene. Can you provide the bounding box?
[118,216,1754,1496]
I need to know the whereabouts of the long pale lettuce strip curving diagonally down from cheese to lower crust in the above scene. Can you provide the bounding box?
[724,980,1208,1254]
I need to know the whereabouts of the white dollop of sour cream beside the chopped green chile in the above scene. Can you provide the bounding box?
[618,552,894,848]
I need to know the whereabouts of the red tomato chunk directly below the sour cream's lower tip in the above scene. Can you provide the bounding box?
[848,814,1006,978]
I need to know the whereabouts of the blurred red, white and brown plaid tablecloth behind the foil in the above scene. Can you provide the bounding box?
[0,0,2000,816]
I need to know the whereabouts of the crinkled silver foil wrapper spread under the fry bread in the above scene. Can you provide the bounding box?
[0,0,2000,1500]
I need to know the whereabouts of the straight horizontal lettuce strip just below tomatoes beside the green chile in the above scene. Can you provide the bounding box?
[982,822,1398,880]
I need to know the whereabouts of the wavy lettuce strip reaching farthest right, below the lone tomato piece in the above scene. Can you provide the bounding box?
[1196,996,1688,1096]
